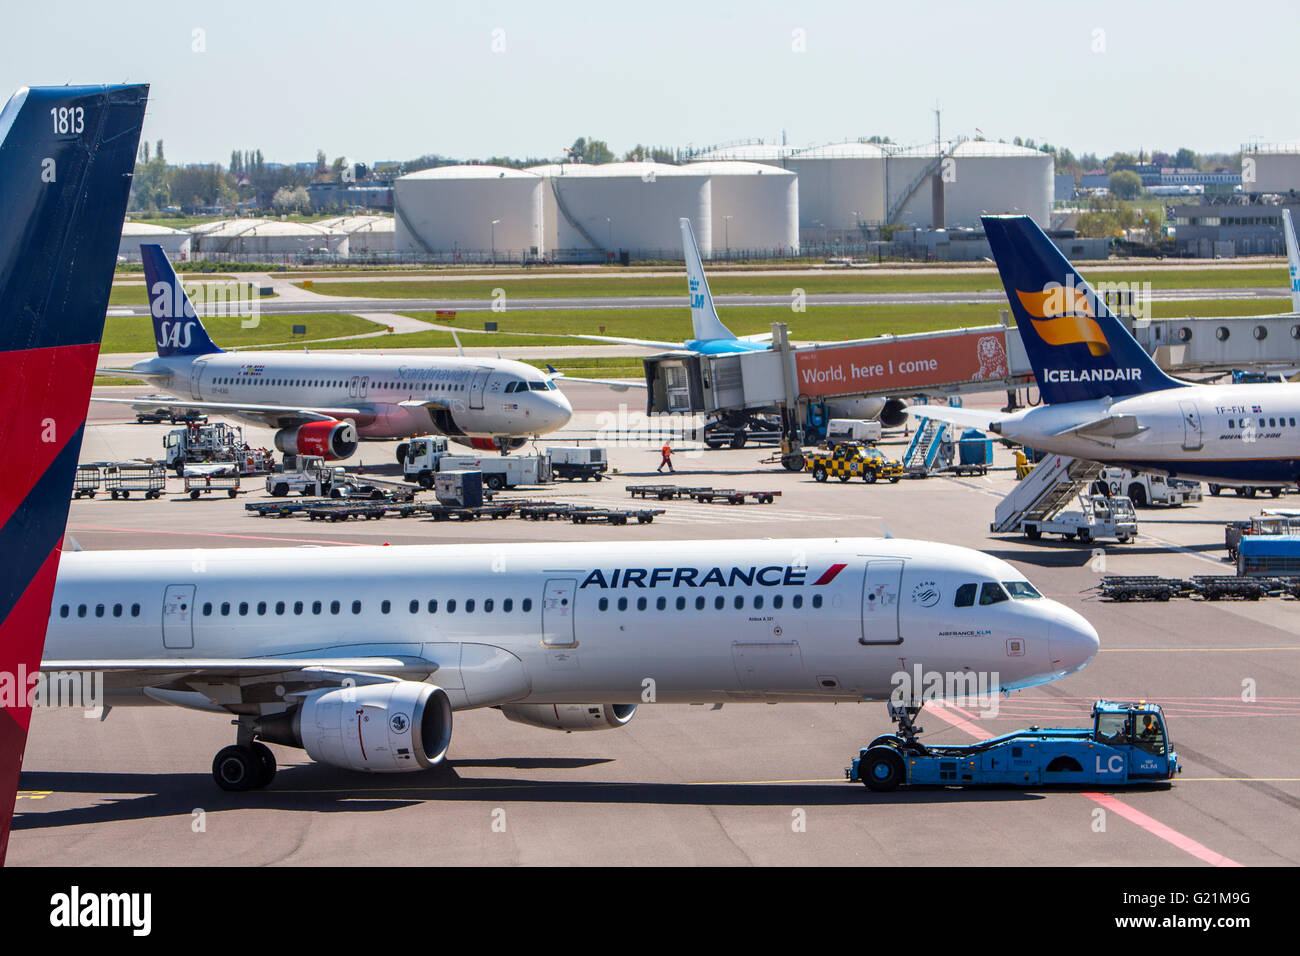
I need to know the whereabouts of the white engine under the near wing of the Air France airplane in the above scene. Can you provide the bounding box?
[256,680,451,774]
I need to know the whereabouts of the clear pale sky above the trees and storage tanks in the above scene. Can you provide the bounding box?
[0,0,1300,163]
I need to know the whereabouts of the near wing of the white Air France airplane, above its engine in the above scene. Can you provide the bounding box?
[40,657,438,713]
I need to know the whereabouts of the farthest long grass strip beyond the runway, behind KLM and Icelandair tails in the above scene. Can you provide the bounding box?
[299,265,1288,300]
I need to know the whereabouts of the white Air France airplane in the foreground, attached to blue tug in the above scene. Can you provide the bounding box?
[42,538,1097,790]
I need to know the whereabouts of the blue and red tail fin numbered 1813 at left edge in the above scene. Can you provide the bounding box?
[0,86,148,862]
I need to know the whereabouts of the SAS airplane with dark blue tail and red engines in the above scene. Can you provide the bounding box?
[95,243,573,459]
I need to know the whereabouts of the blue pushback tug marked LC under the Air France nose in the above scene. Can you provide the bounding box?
[844,700,1182,792]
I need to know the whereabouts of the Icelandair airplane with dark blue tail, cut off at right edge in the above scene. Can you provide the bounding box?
[909,216,1300,486]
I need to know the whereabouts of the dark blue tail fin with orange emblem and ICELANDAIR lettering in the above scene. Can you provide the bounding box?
[982,216,1184,405]
